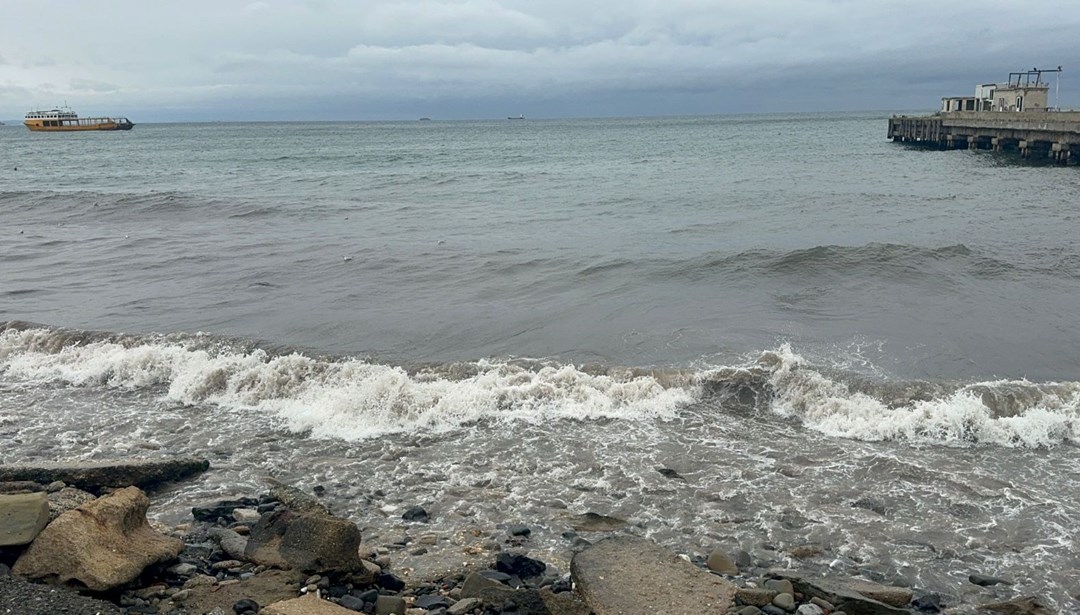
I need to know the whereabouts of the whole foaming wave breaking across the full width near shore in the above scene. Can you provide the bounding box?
[0,322,1080,447]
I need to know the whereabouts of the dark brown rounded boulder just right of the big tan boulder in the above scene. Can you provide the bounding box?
[244,509,366,573]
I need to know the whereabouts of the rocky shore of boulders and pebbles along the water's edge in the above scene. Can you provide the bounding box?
[0,459,1055,615]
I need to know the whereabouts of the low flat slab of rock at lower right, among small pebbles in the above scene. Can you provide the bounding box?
[769,571,912,615]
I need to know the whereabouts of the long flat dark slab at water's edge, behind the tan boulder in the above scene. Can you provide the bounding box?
[0,457,210,493]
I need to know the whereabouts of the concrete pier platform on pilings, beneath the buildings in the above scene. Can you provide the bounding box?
[889,110,1080,164]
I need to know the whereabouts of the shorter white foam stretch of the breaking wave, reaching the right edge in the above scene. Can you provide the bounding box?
[761,345,1080,446]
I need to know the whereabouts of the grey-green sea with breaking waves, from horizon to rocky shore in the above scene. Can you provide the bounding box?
[0,112,1080,613]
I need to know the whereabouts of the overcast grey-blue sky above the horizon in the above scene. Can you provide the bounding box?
[0,0,1080,122]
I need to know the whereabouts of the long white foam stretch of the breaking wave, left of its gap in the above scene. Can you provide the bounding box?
[0,329,693,440]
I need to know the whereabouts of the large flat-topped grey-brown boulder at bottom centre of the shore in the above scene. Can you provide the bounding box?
[570,536,735,615]
